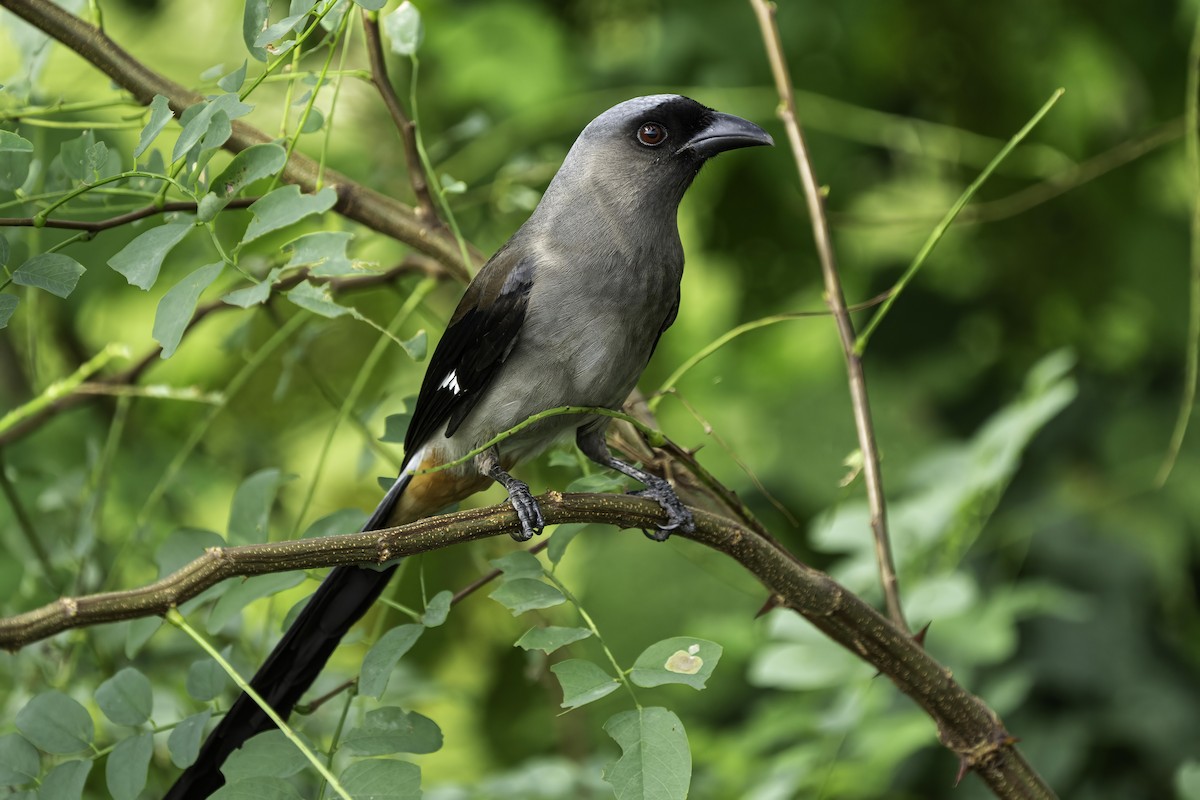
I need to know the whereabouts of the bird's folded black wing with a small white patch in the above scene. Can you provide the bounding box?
[404,246,534,457]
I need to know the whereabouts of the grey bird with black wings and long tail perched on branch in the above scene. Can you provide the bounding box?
[166,95,773,800]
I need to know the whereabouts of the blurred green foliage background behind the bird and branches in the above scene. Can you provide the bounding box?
[0,0,1200,800]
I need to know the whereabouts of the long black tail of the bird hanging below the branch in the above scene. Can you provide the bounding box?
[166,474,409,800]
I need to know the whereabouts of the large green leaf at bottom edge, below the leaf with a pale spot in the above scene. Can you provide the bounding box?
[604,708,691,800]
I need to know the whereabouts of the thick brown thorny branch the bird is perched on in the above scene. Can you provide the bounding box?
[0,492,1055,799]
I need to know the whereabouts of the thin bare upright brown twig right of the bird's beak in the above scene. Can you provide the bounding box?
[750,0,908,630]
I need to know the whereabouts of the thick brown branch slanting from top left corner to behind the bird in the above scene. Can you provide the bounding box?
[0,0,468,282]
